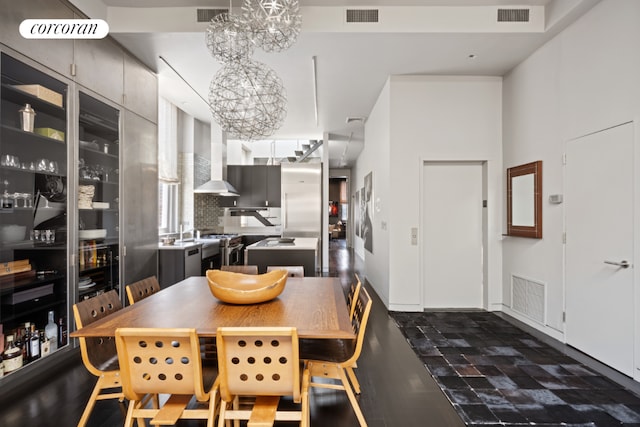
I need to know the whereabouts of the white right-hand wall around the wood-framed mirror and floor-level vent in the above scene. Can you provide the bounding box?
[502,0,640,339]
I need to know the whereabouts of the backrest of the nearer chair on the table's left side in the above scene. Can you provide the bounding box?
[73,289,122,376]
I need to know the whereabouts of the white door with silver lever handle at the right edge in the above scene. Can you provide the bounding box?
[565,123,634,376]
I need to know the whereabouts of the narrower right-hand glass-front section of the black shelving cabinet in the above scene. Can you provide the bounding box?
[77,91,120,300]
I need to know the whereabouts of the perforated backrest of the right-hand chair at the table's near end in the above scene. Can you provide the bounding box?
[216,327,300,402]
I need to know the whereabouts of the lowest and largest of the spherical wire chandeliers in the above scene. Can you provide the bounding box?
[209,59,287,140]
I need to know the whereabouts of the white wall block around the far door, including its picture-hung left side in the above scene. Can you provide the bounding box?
[352,76,502,311]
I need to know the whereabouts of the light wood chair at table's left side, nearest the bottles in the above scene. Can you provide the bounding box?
[73,290,124,427]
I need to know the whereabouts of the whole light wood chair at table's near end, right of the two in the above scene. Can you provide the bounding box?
[216,327,309,427]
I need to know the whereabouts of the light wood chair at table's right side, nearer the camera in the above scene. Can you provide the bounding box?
[305,287,372,427]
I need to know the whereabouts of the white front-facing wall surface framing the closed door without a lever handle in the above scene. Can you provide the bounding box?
[389,76,502,310]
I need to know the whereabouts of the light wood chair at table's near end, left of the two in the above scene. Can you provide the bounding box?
[116,328,219,427]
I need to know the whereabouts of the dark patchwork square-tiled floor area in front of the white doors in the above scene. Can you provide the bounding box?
[390,311,640,426]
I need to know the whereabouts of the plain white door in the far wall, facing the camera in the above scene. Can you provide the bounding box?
[422,162,483,308]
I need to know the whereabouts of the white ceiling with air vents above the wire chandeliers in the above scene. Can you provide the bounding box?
[67,0,598,167]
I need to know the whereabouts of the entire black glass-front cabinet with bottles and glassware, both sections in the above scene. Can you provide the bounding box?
[0,52,122,384]
